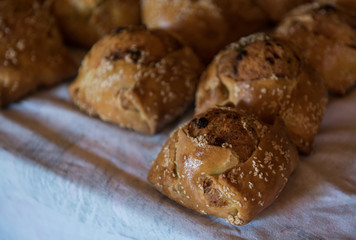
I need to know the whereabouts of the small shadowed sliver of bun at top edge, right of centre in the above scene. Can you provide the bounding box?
[257,0,311,22]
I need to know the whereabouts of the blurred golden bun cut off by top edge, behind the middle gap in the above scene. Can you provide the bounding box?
[142,0,267,63]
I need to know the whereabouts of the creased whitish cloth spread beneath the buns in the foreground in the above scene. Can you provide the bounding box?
[0,83,356,240]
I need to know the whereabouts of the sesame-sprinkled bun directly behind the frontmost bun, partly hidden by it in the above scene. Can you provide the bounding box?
[196,33,327,154]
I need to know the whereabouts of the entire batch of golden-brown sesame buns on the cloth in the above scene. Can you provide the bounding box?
[0,0,356,225]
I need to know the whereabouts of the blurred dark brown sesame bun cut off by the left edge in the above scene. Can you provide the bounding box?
[0,0,77,107]
